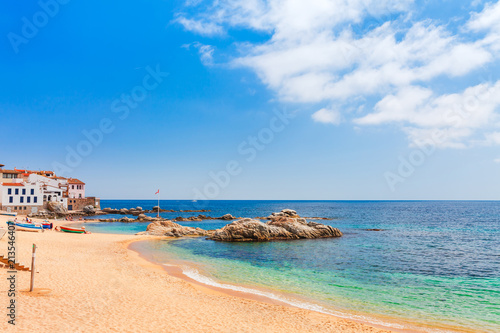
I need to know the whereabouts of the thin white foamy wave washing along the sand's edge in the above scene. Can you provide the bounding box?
[173,264,450,333]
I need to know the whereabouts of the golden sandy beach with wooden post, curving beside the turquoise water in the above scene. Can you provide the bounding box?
[0,216,396,332]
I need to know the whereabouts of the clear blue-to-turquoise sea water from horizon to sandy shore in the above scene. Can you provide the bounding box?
[86,201,500,332]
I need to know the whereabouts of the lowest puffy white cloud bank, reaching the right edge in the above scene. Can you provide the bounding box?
[354,81,500,148]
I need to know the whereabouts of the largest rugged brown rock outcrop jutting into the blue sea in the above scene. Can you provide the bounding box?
[208,213,342,242]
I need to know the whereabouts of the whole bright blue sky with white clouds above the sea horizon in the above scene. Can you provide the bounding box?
[0,0,500,200]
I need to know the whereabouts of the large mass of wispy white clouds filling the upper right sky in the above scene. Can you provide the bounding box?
[179,0,500,148]
